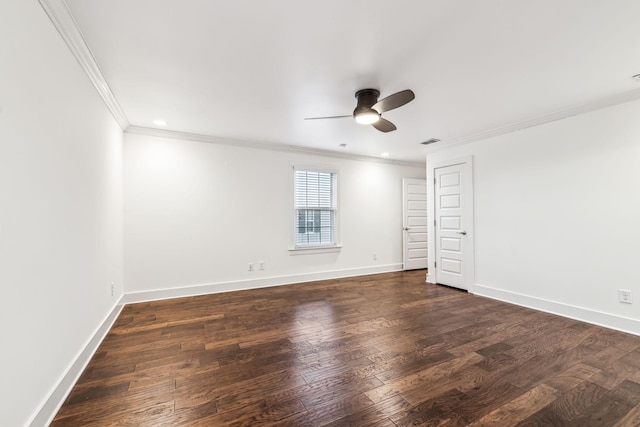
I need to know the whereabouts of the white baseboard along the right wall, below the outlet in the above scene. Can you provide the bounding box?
[473,284,640,335]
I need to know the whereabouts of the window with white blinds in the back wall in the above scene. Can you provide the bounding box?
[294,169,337,249]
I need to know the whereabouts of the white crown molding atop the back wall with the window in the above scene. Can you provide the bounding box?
[125,125,426,168]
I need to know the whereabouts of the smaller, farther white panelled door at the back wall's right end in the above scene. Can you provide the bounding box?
[402,178,427,270]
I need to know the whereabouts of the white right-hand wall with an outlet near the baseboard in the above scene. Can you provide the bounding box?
[427,101,640,334]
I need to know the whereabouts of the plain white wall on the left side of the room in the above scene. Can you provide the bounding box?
[0,1,122,426]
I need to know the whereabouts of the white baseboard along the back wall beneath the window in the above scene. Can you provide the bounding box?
[122,264,402,304]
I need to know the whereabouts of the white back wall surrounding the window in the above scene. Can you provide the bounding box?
[124,134,425,300]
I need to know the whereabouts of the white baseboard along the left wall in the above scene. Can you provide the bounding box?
[28,300,124,427]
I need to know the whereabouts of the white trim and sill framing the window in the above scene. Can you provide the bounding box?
[288,164,342,255]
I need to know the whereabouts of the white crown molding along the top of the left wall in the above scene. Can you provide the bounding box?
[38,0,129,131]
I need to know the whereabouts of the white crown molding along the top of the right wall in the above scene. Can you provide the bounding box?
[423,89,640,153]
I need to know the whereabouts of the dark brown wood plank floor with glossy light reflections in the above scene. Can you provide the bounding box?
[52,271,640,426]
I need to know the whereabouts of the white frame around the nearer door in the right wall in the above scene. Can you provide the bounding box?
[427,156,476,293]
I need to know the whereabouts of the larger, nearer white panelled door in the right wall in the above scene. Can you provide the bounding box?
[434,163,473,290]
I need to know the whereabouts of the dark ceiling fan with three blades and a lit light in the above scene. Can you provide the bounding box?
[305,89,416,132]
